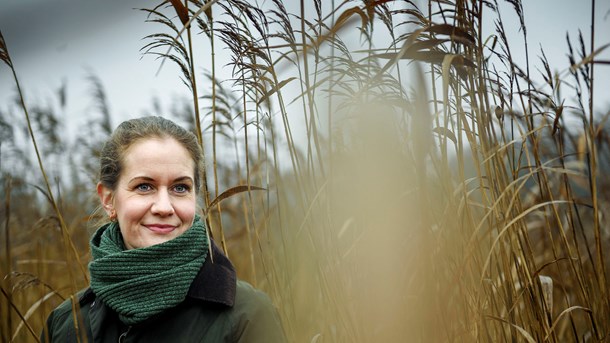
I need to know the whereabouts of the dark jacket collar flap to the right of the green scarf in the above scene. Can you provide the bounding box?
[187,241,237,307]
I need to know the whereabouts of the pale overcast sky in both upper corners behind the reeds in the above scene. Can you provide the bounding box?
[0,0,610,138]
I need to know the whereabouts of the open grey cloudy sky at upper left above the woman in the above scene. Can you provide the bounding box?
[0,0,188,134]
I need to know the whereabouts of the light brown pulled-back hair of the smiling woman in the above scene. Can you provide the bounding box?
[99,116,203,194]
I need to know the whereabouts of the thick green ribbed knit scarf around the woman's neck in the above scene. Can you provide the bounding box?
[89,216,209,325]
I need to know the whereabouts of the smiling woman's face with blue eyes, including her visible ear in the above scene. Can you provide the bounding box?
[97,138,197,249]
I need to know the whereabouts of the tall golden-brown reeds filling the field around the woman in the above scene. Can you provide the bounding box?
[0,0,610,343]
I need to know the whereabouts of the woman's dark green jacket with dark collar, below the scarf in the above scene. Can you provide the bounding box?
[42,245,286,343]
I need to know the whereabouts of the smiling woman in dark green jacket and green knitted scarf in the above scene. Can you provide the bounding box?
[42,117,285,342]
